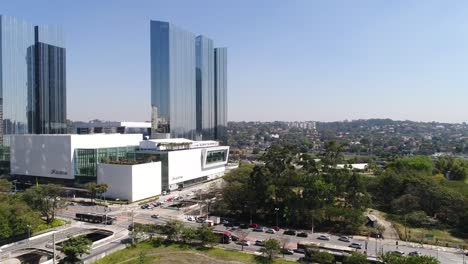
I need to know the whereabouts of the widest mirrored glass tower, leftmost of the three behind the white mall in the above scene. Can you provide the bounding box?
[150,21,196,139]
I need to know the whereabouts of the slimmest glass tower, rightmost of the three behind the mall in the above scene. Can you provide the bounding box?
[214,48,227,144]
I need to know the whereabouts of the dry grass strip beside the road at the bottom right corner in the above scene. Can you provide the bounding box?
[393,222,468,247]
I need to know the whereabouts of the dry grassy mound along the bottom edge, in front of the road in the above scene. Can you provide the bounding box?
[95,242,296,264]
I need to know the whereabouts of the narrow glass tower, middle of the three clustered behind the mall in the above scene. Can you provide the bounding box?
[195,36,216,140]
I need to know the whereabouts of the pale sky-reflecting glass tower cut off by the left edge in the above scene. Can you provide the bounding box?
[0,16,35,146]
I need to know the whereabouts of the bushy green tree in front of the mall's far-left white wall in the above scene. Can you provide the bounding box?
[23,184,65,224]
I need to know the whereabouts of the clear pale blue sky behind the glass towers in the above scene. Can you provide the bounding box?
[0,0,468,122]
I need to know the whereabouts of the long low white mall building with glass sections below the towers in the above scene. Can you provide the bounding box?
[10,134,229,202]
